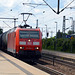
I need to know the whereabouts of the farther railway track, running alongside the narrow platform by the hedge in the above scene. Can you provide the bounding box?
[41,54,75,68]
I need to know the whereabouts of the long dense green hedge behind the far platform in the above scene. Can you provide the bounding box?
[42,38,75,53]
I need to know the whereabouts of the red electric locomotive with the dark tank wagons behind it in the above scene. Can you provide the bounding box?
[0,27,42,59]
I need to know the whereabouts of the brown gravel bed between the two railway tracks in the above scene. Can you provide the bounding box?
[40,59,75,75]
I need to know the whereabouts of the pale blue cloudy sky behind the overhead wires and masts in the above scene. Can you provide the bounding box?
[0,0,75,38]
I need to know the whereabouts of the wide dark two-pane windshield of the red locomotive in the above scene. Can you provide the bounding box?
[19,30,39,39]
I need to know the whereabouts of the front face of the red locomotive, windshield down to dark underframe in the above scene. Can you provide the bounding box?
[18,29,42,58]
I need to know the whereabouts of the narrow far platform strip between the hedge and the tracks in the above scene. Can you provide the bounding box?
[42,49,75,60]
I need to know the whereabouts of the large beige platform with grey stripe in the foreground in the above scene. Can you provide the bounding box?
[0,51,50,75]
